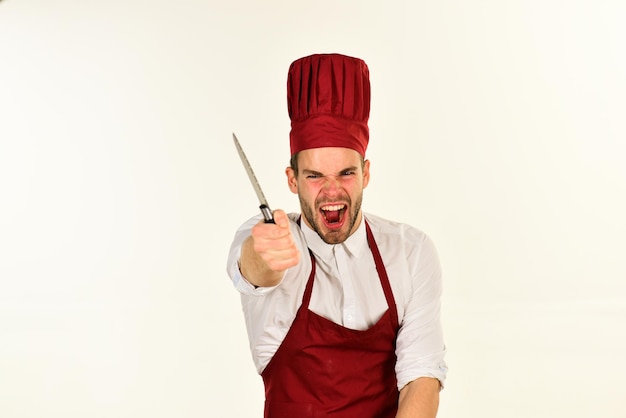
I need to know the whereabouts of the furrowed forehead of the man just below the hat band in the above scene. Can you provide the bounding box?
[298,147,362,173]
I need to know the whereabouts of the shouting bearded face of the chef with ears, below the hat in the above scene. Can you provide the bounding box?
[286,147,370,244]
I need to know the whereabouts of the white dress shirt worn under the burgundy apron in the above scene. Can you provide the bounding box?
[227,213,447,389]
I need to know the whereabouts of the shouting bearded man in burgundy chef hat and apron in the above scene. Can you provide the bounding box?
[228,54,447,418]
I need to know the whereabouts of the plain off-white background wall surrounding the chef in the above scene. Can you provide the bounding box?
[0,0,626,418]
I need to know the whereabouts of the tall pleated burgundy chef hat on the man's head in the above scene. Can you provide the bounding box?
[287,54,370,156]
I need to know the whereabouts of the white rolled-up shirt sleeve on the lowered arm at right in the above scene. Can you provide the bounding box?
[396,235,448,390]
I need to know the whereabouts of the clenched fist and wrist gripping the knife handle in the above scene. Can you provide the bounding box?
[239,210,300,287]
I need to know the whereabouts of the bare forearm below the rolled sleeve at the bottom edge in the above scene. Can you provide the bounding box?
[396,377,440,418]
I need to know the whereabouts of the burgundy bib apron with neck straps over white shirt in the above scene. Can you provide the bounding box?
[261,222,399,418]
